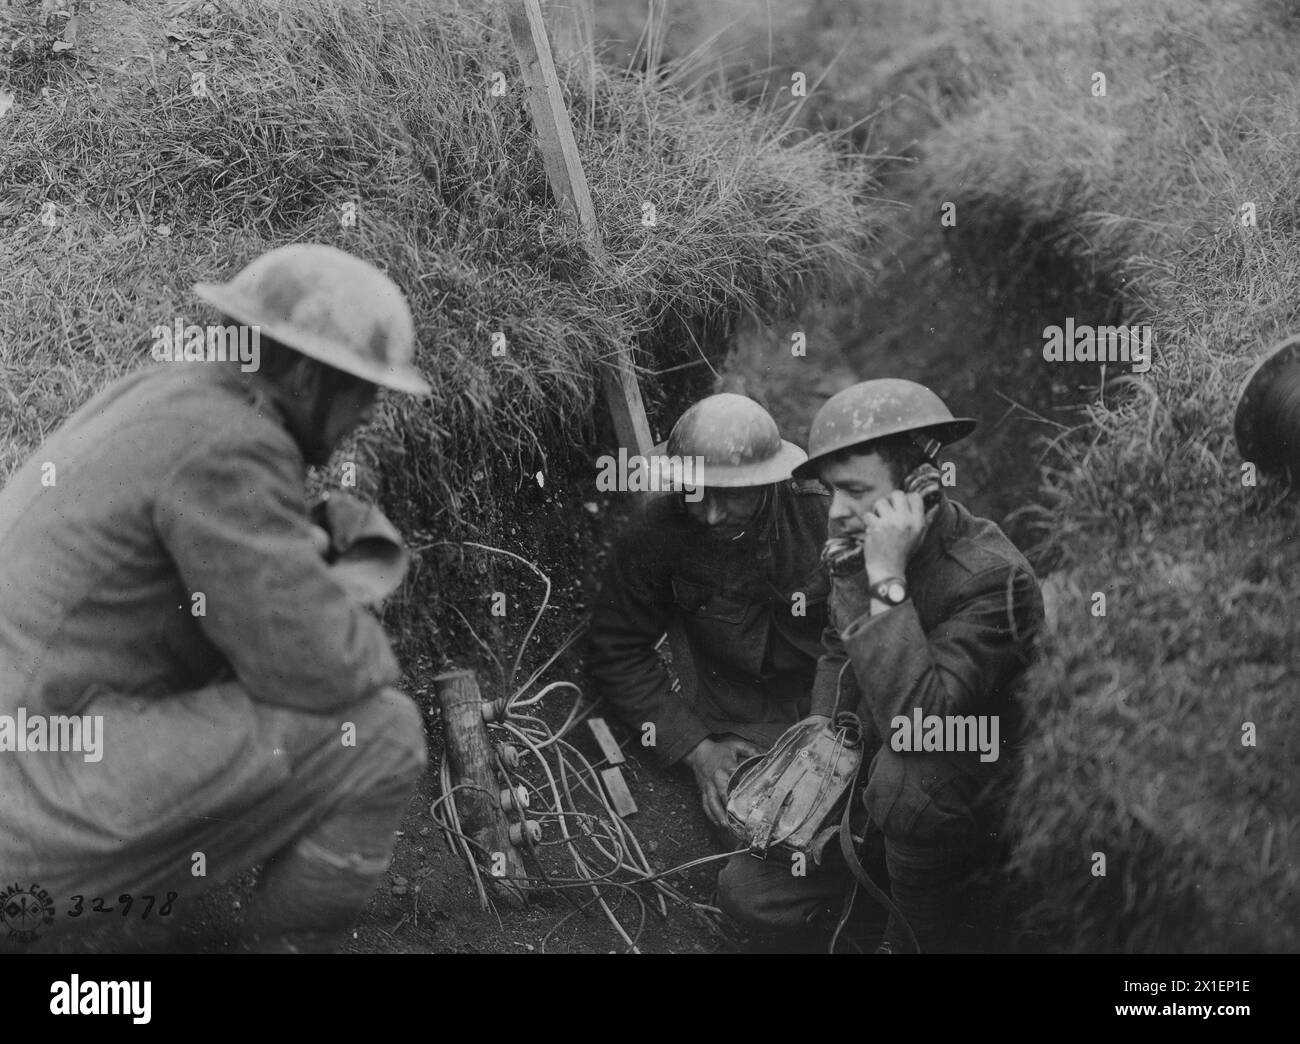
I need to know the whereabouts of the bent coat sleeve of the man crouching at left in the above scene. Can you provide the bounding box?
[155,423,399,712]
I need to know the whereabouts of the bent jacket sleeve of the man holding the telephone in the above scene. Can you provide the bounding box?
[839,564,1043,737]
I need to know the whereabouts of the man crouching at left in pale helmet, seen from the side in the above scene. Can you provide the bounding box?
[0,244,430,952]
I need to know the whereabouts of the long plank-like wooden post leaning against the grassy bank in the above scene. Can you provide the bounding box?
[506,0,653,455]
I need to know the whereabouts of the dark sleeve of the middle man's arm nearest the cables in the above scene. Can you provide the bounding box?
[586,519,709,764]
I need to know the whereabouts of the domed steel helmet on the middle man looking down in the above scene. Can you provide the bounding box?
[651,391,807,489]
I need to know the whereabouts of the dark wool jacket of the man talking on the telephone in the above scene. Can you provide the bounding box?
[813,498,1043,761]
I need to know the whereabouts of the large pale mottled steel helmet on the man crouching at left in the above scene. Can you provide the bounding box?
[194,243,432,395]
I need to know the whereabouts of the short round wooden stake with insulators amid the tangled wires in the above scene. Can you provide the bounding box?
[433,671,528,906]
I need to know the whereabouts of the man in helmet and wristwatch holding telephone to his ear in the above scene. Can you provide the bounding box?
[719,380,1043,952]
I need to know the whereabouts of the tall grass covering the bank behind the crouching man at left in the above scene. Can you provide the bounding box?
[0,0,875,533]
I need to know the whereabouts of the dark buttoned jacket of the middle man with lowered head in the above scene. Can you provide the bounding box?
[588,481,829,763]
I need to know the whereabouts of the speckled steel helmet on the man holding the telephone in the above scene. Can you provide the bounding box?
[794,377,975,478]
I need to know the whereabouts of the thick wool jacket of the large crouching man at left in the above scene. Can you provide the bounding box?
[0,364,399,712]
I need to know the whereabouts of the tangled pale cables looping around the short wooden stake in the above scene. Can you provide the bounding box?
[415,541,744,953]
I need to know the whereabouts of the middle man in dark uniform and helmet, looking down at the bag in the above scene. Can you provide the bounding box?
[588,393,828,828]
